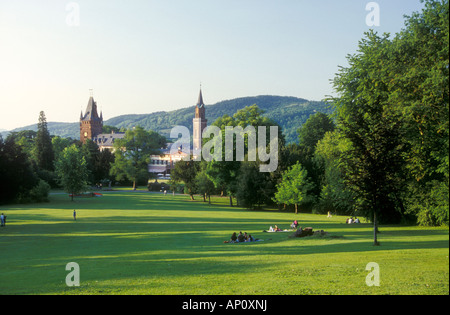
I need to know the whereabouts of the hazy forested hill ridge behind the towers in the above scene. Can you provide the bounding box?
[3,96,332,143]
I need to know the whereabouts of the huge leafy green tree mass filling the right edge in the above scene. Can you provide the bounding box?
[332,0,449,231]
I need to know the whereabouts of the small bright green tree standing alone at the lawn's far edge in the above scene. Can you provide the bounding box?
[273,163,312,214]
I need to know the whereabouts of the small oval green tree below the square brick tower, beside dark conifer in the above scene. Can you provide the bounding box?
[55,144,89,201]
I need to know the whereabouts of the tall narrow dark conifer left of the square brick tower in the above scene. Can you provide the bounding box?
[35,111,55,171]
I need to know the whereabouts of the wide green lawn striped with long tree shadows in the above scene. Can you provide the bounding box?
[0,190,449,295]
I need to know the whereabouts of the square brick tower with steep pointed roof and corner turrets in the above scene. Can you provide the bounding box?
[80,93,103,143]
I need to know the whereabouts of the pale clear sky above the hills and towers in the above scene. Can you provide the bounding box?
[0,0,423,130]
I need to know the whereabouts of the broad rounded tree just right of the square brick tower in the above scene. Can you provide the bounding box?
[110,126,166,189]
